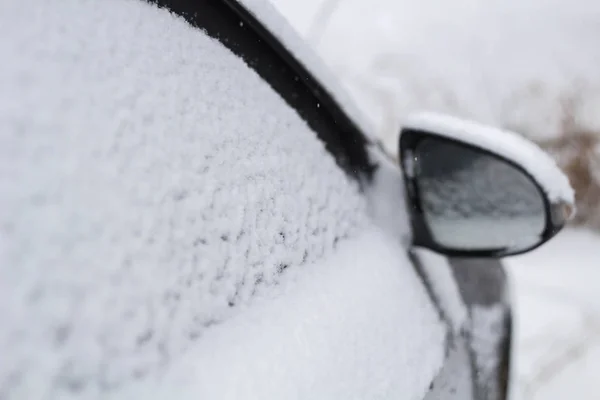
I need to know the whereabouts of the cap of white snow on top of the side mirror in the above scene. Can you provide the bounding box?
[403,112,575,204]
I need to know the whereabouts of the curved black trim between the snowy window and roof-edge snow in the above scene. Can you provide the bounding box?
[145,0,375,184]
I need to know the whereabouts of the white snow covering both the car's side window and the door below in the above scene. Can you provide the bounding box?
[0,0,444,399]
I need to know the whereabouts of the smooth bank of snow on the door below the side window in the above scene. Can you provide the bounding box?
[118,229,445,400]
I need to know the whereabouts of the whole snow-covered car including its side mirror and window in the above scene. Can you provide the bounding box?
[0,0,573,399]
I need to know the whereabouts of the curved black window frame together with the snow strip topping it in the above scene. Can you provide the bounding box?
[149,0,374,183]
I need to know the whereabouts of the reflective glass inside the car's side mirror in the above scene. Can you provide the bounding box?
[414,138,546,251]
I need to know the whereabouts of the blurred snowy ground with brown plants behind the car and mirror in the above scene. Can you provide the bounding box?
[271,0,600,399]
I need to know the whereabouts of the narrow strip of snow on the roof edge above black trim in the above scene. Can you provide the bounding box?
[238,0,375,142]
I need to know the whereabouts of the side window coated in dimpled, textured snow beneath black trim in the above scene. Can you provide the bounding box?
[0,1,367,398]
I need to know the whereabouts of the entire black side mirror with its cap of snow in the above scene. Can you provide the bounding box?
[398,113,575,257]
